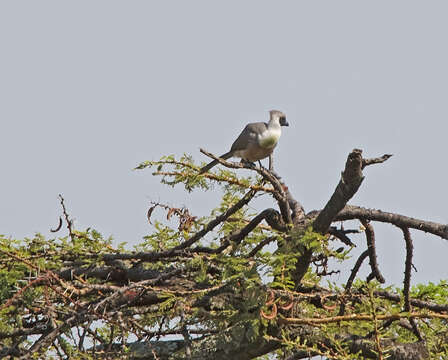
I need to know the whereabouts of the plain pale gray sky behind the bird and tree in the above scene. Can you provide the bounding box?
[0,0,448,283]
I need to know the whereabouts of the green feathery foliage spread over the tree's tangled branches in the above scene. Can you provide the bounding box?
[0,155,448,359]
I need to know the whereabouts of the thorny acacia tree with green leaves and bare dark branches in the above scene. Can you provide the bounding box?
[0,149,448,360]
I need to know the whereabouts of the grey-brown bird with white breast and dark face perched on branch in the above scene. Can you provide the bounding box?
[199,110,289,174]
